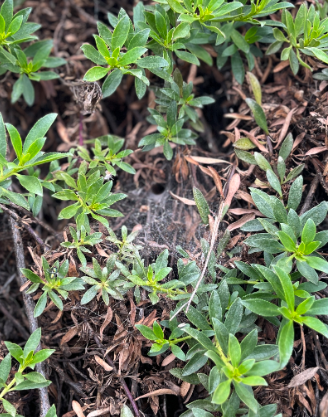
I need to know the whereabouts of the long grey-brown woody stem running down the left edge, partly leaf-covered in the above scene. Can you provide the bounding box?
[10,217,50,417]
